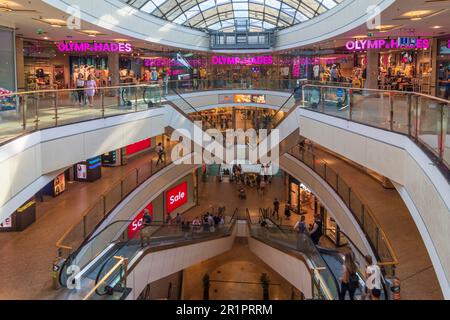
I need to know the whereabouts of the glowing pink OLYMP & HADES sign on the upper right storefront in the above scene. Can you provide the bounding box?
[345,37,430,51]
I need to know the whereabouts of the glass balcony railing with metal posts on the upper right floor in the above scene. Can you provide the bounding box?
[302,84,450,181]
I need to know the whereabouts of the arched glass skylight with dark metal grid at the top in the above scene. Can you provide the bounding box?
[121,0,344,32]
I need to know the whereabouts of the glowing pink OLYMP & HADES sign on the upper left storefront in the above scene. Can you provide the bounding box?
[57,42,133,53]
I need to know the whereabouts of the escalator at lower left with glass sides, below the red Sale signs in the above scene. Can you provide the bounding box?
[59,209,238,300]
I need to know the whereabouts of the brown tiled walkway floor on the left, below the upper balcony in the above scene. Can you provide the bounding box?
[0,148,163,299]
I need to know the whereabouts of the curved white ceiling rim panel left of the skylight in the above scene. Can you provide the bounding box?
[43,0,209,51]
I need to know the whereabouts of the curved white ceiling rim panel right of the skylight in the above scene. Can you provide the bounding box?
[274,0,395,50]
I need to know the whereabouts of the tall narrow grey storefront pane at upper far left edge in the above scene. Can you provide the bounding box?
[0,27,16,91]
